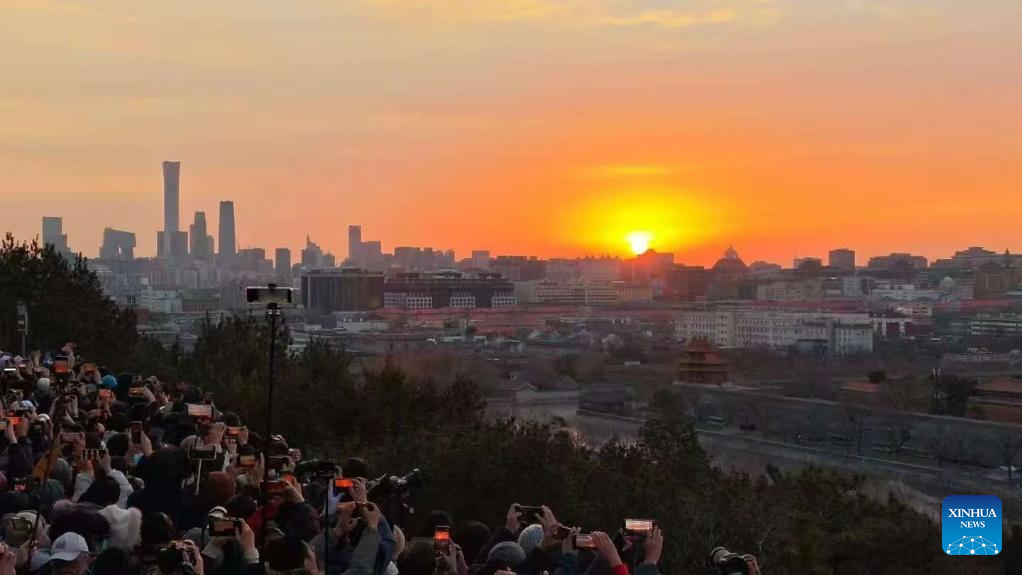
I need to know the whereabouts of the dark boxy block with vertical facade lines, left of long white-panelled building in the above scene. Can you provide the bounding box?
[301,268,383,314]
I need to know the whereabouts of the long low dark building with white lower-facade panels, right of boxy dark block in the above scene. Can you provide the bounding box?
[383,272,517,309]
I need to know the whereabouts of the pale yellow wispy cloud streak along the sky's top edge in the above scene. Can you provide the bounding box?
[363,0,777,29]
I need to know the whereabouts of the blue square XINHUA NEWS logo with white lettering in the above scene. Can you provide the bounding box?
[940,495,1002,555]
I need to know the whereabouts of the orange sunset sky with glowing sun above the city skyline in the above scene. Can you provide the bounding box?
[0,0,1022,263]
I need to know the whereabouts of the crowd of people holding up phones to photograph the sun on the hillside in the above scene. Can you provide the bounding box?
[0,343,694,575]
